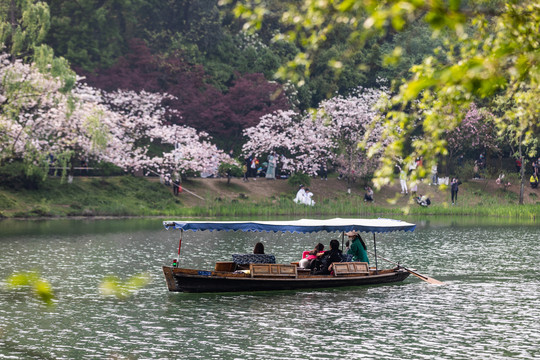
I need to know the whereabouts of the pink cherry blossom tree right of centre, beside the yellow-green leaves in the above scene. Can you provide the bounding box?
[243,88,385,180]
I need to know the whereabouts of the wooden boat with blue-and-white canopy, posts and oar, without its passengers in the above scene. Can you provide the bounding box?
[163,219,420,292]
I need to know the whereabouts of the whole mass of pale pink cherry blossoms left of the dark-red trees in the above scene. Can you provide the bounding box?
[0,54,228,181]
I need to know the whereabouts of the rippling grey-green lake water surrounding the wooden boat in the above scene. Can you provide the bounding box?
[0,218,540,359]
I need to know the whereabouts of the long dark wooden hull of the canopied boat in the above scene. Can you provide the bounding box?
[163,266,409,292]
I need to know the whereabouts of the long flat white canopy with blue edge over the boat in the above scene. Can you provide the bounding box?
[163,218,416,233]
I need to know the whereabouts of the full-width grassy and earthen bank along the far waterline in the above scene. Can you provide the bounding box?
[0,176,540,219]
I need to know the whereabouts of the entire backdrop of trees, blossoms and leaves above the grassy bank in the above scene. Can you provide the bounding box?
[0,0,540,208]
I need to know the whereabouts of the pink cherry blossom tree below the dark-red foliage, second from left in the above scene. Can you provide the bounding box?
[93,90,229,176]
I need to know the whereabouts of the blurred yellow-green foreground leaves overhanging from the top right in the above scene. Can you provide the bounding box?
[236,0,540,200]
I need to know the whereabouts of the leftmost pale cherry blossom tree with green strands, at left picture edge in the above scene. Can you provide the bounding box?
[0,54,106,172]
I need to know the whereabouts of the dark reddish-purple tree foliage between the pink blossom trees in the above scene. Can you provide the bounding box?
[81,40,289,146]
